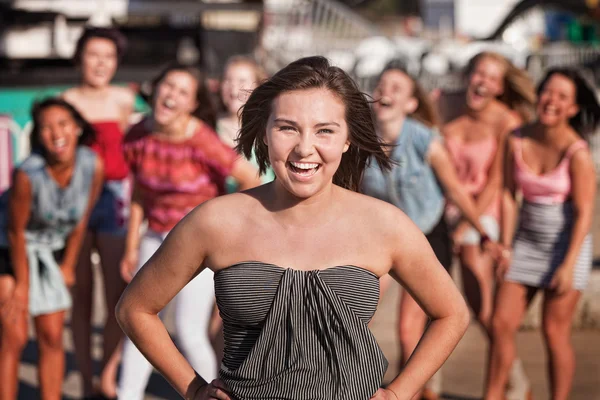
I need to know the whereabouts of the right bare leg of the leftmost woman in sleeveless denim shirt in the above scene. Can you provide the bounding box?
[34,311,65,400]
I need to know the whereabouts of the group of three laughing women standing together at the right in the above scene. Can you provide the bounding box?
[363,52,600,400]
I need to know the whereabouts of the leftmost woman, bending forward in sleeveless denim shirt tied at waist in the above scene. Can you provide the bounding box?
[0,98,103,399]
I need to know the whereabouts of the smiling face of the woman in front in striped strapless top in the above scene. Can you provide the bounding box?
[264,88,350,199]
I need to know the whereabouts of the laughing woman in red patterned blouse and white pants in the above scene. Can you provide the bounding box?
[118,65,260,400]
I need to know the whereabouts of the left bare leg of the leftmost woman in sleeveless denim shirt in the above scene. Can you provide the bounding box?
[0,275,27,400]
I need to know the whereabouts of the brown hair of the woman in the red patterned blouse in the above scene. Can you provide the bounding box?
[151,63,217,129]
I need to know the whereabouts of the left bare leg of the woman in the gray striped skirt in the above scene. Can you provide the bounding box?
[485,282,536,400]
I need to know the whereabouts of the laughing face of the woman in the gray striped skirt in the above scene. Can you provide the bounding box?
[537,74,579,126]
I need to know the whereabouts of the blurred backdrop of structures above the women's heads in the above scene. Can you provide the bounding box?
[0,0,600,175]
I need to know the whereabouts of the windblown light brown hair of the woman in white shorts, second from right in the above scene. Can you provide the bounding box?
[466,51,537,123]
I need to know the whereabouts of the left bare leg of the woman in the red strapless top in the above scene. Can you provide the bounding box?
[71,232,94,397]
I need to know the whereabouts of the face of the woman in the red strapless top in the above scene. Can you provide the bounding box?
[81,37,118,87]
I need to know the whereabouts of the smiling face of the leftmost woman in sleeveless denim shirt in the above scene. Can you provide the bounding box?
[39,106,81,163]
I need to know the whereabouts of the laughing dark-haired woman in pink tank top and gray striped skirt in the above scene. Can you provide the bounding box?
[485,69,600,400]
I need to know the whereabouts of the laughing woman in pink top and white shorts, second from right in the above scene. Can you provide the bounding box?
[443,52,535,398]
